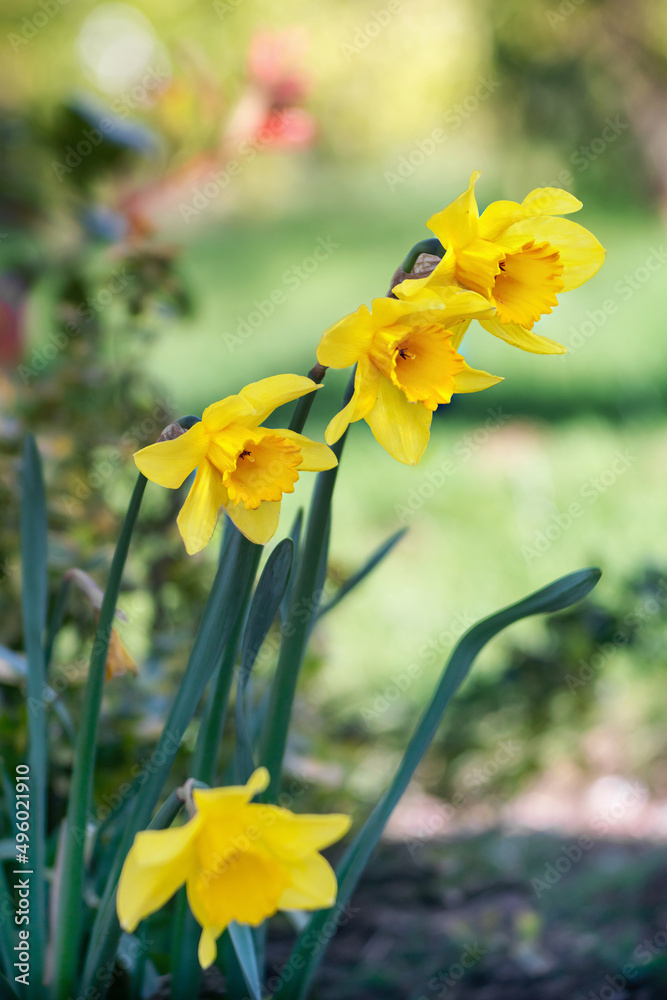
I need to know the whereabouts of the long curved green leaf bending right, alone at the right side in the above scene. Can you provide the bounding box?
[274,569,601,1000]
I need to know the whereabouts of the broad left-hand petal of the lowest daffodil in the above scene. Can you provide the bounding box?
[116,822,198,933]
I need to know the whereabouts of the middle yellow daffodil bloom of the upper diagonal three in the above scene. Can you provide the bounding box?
[317,288,501,465]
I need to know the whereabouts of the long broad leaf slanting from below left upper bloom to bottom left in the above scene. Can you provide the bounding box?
[82,530,257,1000]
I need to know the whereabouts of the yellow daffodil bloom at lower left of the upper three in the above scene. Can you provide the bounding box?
[134,375,337,554]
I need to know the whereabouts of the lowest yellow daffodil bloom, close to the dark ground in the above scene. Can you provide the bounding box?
[116,768,350,969]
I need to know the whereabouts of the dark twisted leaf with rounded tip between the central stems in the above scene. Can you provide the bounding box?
[235,538,294,784]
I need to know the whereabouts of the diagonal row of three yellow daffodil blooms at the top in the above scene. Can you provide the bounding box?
[135,172,605,552]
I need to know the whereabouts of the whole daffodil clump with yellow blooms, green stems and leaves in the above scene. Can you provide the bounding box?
[10,174,604,1000]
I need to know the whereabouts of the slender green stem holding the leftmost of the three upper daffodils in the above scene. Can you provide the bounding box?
[52,474,147,1000]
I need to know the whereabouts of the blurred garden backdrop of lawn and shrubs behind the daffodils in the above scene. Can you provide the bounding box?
[0,0,667,834]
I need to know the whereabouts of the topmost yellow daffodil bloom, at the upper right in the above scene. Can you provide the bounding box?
[394,171,605,354]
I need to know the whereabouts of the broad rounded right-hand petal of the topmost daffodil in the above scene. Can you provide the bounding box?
[507,216,606,292]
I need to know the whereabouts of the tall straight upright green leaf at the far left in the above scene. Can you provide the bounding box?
[21,434,48,996]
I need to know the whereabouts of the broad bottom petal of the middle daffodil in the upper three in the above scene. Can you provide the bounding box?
[366,377,433,465]
